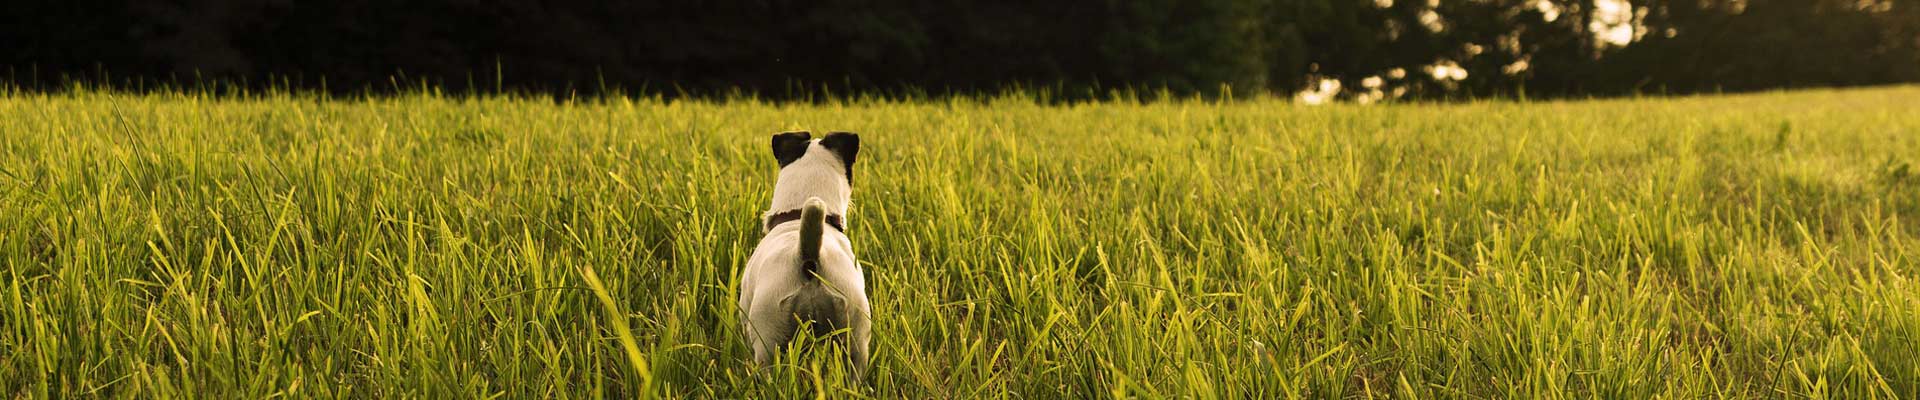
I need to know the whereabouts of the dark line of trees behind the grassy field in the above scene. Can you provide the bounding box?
[0,0,1920,96]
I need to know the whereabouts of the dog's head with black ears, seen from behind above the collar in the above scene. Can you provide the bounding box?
[768,131,860,215]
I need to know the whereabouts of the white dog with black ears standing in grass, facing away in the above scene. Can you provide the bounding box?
[739,131,872,381]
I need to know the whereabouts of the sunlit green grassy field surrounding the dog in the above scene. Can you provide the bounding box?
[0,87,1920,398]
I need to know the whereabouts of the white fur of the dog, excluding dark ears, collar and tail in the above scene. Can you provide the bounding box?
[739,133,872,379]
